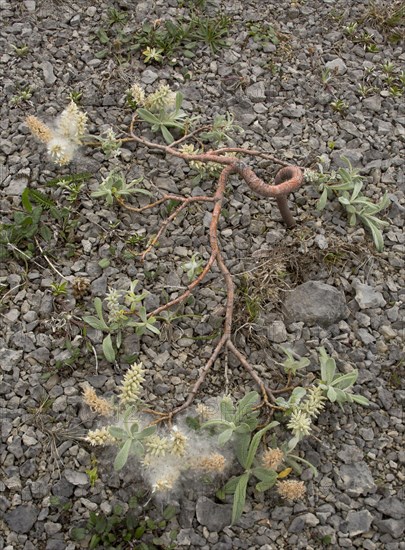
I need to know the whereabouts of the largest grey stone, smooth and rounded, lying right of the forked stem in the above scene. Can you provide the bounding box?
[283,281,348,327]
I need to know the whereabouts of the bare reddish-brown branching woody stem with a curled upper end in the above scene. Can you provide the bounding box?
[119,117,303,423]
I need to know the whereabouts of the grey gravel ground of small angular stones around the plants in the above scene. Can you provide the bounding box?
[0,0,405,550]
